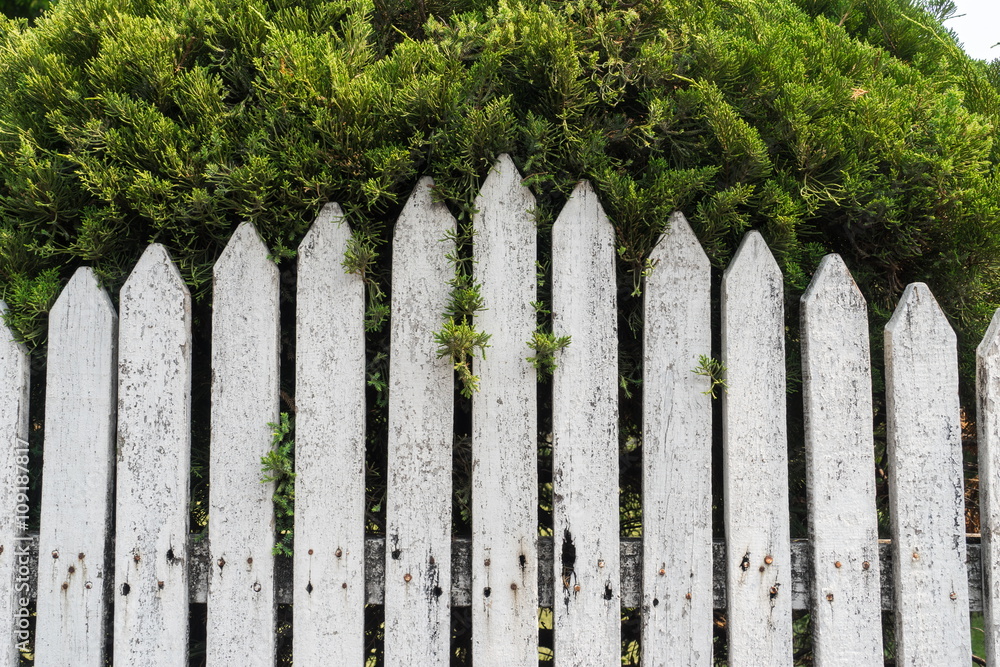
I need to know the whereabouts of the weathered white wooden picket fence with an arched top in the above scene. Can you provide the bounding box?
[0,156,1000,667]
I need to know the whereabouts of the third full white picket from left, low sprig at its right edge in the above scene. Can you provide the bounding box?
[207,223,279,667]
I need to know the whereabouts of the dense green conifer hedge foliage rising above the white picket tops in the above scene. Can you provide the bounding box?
[0,0,1000,366]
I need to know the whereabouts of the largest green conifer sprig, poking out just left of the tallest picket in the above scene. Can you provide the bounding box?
[434,230,490,398]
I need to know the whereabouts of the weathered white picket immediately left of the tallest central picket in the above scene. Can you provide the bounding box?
[385,178,456,667]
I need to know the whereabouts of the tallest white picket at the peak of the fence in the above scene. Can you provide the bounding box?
[472,155,538,667]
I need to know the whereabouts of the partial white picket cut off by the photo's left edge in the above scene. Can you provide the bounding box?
[0,301,31,667]
